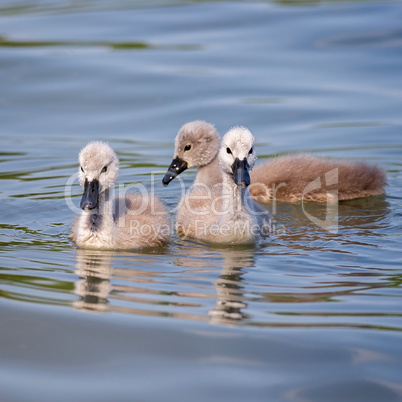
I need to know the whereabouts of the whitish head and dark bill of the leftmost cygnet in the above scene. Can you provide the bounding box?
[78,142,119,210]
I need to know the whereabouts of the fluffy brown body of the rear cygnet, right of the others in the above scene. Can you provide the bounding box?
[250,154,386,203]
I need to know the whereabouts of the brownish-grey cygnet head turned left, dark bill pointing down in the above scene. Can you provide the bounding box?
[162,120,220,186]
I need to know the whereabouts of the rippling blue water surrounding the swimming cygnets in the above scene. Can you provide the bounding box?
[0,0,402,402]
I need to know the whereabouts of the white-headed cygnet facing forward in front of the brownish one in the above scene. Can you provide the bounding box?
[176,127,270,244]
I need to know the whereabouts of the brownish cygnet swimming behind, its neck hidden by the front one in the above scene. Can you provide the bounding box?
[163,121,386,203]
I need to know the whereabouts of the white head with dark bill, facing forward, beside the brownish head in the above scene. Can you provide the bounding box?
[218,127,257,188]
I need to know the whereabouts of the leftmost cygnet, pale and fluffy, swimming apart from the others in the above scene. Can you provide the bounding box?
[70,142,171,249]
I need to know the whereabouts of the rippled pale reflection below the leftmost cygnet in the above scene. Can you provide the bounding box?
[73,249,179,315]
